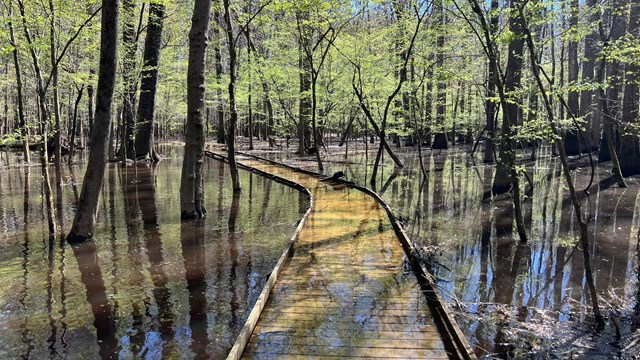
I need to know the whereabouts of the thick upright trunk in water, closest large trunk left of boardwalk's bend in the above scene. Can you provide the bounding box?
[180,0,211,219]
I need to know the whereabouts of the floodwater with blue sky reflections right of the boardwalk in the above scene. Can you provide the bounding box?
[258,142,640,358]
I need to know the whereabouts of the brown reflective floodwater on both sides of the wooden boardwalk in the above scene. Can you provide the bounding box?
[0,141,640,359]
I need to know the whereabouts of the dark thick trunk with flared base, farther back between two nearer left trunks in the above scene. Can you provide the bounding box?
[135,2,165,162]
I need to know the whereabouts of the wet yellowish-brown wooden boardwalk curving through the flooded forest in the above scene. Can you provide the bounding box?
[208,153,473,359]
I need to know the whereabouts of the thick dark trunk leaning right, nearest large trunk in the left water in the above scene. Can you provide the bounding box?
[67,0,118,243]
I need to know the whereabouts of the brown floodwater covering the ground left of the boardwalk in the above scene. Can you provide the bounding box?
[0,147,309,359]
